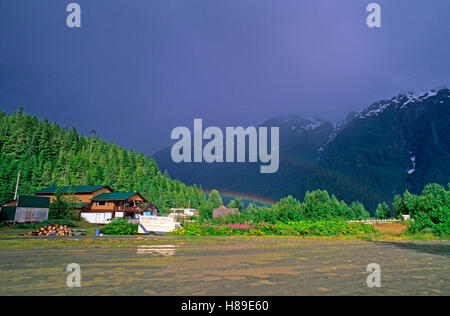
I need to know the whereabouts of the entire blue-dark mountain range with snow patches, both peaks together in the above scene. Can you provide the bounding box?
[154,88,450,212]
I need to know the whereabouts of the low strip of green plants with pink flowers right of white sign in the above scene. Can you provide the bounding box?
[170,221,376,236]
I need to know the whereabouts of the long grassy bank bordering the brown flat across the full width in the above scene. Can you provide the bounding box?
[0,218,450,249]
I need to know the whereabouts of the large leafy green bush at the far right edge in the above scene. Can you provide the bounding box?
[394,183,450,236]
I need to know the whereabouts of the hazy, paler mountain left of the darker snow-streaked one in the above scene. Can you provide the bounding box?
[153,116,334,200]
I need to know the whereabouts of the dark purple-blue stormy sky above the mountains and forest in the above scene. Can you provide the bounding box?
[0,0,450,154]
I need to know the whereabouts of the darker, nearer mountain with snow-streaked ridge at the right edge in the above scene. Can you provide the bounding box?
[318,89,450,210]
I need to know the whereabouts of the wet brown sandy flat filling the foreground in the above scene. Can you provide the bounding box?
[0,238,450,295]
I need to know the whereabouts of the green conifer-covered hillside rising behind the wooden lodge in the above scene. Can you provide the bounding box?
[0,110,206,210]
